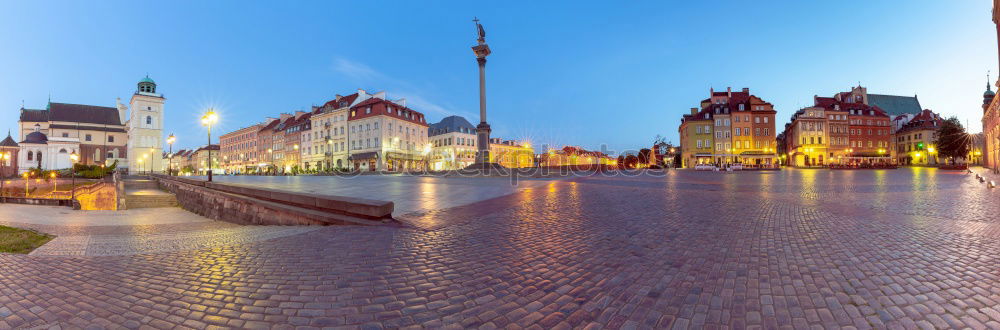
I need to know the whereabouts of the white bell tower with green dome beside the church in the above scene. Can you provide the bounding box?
[128,75,166,174]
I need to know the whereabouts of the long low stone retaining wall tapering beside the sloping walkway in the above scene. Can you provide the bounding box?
[152,175,393,225]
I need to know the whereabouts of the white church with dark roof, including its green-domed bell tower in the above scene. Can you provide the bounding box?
[10,77,164,176]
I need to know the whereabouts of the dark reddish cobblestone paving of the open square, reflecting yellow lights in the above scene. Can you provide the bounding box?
[0,169,1000,329]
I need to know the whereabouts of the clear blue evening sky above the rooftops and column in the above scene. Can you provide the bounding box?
[0,0,997,151]
